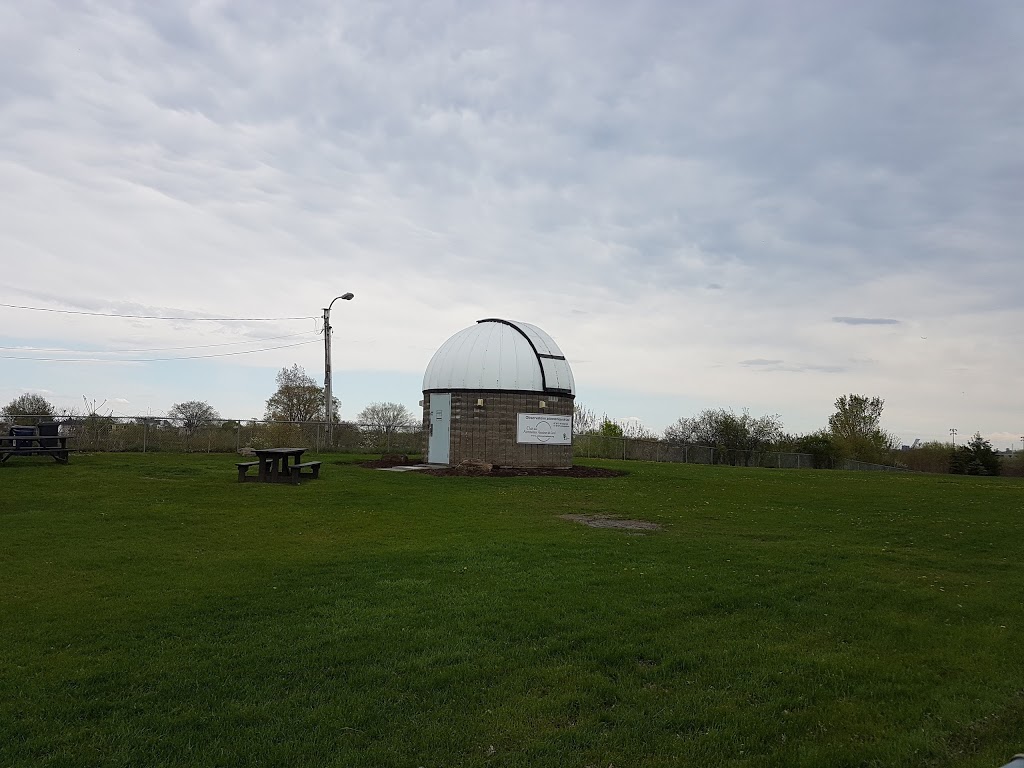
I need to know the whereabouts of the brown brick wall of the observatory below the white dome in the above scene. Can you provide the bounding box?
[423,392,573,467]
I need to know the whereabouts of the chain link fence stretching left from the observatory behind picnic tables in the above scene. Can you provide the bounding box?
[0,415,424,455]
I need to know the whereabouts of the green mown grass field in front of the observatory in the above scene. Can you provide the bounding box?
[0,455,1024,768]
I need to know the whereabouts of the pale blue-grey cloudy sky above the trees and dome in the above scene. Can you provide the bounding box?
[0,0,1024,447]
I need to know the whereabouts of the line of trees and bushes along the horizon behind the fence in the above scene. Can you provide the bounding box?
[0,385,1024,475]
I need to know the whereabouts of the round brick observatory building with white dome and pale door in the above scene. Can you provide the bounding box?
[423,317,575,467]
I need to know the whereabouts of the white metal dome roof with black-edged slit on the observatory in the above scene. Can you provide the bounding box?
[423,317,575,395]
